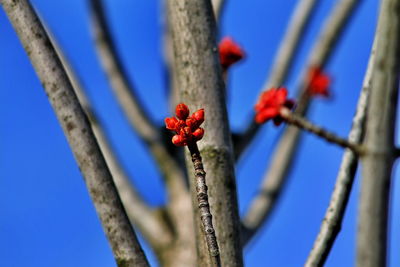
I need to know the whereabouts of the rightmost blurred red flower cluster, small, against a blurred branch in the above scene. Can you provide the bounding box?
[307,67,331,97]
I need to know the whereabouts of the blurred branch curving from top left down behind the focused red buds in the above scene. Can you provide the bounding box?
[90,0,186,194]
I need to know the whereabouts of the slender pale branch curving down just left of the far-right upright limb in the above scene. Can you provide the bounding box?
[305,41,375,267]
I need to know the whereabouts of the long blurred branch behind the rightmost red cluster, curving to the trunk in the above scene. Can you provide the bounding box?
[242,0,360,244]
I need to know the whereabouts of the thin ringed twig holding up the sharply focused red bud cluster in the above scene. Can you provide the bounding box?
[188,142,221,266]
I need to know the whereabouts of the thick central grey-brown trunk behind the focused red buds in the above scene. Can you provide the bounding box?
[167,0,243,266]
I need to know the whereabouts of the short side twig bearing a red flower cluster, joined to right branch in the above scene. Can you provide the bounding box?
[280,108,362,154]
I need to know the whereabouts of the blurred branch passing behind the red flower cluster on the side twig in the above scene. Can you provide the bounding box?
[235,0,318,158]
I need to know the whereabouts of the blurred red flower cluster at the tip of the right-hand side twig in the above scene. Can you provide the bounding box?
[254,87,294,125]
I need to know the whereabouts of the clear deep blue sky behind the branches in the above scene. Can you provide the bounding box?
[0,0,400,267]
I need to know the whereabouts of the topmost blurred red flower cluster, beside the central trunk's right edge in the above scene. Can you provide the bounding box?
[219,37,245,70]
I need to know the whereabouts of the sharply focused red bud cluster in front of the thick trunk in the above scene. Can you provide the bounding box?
[165,103,204,146]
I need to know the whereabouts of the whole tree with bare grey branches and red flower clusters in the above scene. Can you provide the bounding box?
[0,0,400,266]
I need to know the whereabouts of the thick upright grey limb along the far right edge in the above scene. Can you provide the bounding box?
[357,0,400,267]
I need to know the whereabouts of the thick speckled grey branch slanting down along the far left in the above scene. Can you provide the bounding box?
[0,0,148,266]
